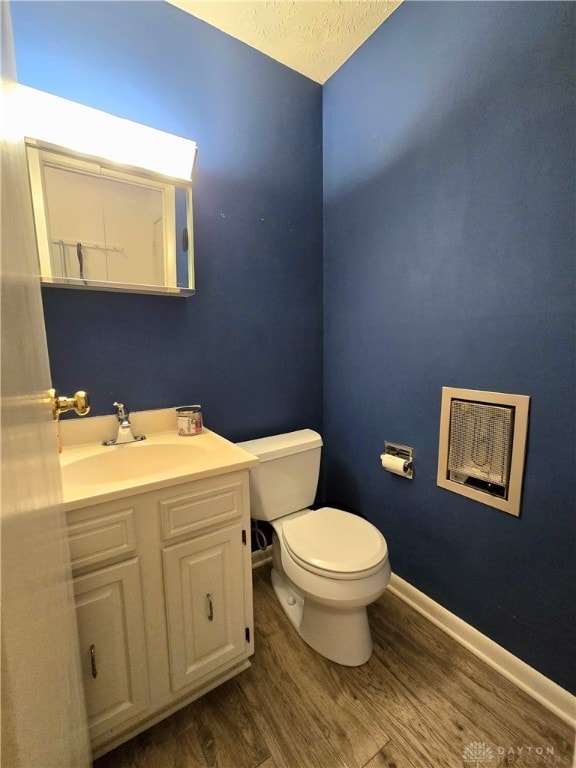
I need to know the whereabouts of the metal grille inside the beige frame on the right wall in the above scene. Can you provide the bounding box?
[448,400,514,487]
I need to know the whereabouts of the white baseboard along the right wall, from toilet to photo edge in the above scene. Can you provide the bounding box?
[388,573,576,728]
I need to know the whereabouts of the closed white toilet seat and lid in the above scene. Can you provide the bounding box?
[282,507,388,580]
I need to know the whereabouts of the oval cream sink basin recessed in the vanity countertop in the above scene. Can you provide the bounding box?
[62,443,206,485]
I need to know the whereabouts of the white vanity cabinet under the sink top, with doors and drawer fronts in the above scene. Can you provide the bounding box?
[67,470,254,756]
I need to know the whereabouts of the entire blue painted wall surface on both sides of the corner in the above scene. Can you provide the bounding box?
[12,2,576,690]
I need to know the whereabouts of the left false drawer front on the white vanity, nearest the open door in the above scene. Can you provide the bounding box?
[68,506,136,571]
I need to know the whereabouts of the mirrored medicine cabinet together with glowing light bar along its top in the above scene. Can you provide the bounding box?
[20,86,196,296]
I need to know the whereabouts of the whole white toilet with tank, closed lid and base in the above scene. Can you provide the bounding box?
[239,429,390,667]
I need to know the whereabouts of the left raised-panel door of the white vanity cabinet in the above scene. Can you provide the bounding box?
[74,558,148,739]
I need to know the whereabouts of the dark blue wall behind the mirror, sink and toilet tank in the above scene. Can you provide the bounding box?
[12,2,322,440]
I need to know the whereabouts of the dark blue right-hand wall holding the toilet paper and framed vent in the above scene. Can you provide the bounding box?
[324,2,576,690]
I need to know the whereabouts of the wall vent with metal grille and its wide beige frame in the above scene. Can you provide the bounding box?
[437,387,530,517]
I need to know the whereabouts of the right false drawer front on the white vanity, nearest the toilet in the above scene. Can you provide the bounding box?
[160,475,243,541]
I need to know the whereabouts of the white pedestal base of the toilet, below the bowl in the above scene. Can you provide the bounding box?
[272,568,372,667]
